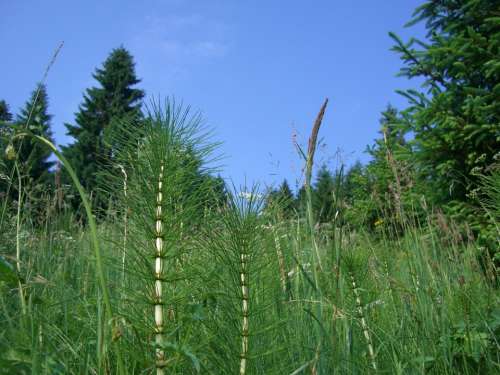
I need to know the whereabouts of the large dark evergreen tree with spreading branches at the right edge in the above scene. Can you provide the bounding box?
[391,0,500,206]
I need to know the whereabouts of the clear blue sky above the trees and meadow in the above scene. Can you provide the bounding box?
[0,0,424,191]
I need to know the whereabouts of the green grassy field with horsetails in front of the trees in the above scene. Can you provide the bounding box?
[0,105,500,375]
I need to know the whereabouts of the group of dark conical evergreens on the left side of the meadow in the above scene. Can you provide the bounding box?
[0,47,224,217]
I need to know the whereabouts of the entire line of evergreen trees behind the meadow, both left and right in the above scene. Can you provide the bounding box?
[0,0,500,256]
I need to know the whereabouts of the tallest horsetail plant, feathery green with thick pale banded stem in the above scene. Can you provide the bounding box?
[106,100,220,375]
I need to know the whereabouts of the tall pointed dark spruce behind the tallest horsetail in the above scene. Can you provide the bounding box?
[64,47,144,208]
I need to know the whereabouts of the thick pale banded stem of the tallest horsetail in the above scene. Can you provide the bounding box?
[154,163,165,375]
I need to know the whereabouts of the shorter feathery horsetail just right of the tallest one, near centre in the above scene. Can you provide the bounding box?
[196,189,282,375]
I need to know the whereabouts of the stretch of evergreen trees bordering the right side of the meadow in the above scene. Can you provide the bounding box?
[268,0,500,254]
